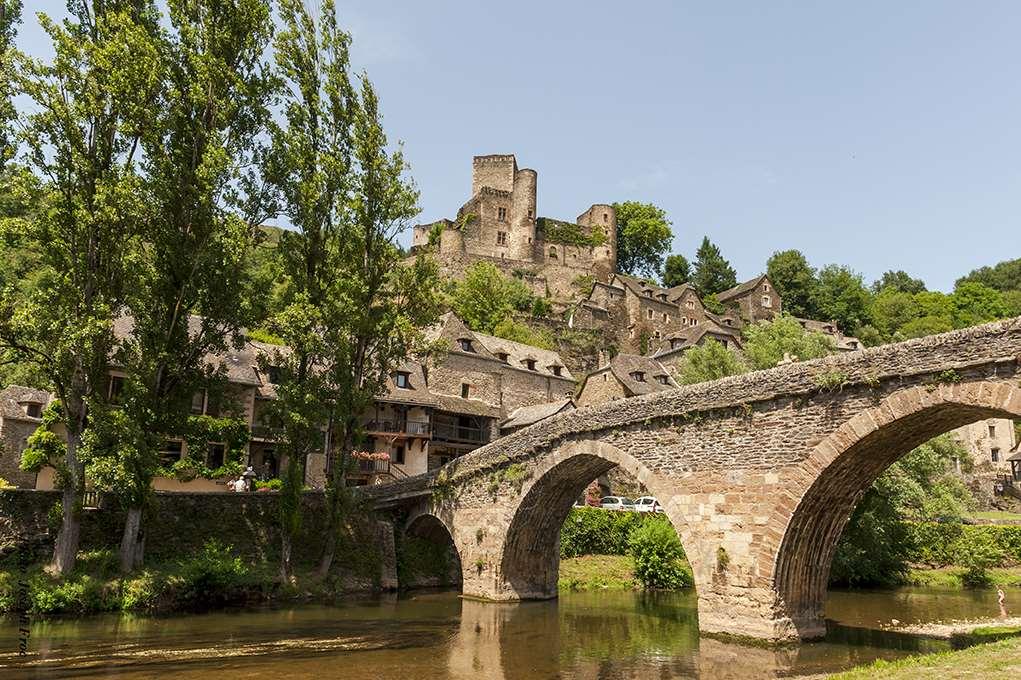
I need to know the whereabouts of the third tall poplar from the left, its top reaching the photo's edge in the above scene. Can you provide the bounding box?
[259,0,361,582]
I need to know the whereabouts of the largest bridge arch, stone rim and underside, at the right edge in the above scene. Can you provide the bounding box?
[774,380,1021,638]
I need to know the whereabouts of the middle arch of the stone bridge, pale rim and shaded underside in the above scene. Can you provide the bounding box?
[500,439,700,599]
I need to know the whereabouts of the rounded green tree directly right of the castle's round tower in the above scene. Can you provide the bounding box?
[614,201,674,276]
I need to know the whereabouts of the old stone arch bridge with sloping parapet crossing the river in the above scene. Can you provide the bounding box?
[367,319,1021,640]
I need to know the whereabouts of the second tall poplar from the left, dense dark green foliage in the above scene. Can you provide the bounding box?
[97,0,272,572]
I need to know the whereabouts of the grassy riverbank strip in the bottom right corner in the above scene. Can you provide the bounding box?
[829,638,1021,680]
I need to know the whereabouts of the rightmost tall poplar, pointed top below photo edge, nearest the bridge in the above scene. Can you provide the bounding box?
[320,76,440,576]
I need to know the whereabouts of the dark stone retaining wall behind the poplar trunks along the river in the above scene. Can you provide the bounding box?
[0,489,396,589]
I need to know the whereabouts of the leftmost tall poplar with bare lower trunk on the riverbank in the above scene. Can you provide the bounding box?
[0,0,159,575]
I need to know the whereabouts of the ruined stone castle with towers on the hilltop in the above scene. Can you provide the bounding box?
[411,154,617,298]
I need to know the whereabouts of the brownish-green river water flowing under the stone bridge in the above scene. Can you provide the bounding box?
[0,589,1021,680]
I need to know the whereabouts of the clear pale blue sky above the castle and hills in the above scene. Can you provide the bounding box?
[18,0,1021,291]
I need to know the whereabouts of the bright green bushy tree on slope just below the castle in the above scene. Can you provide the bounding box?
[451,261,536,335]
